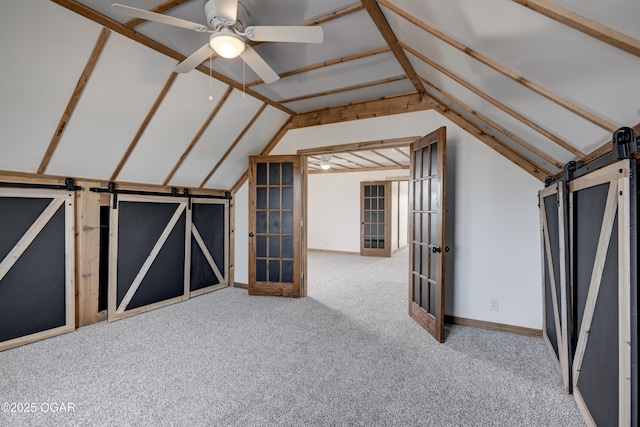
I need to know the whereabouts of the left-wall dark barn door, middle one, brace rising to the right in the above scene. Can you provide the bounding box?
[108,195,191,320]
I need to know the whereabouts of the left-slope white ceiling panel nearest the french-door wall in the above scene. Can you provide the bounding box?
[205,107,289,190]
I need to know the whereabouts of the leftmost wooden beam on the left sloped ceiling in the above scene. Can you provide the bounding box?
[37,28,111,174]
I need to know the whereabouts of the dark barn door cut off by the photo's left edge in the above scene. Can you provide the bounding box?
[0,189,75,350]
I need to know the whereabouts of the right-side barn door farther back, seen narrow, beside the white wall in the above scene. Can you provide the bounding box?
[539,182,572,393]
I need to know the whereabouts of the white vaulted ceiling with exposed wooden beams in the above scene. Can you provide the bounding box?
[0,0,640,189]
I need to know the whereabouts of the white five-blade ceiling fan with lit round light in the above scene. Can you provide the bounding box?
[111,0,324,83]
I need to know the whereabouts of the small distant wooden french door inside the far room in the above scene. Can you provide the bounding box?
[360,181,391,256]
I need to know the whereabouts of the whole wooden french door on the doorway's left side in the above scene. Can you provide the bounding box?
[249,156,306,297]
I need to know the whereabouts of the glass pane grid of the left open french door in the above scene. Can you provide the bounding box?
[255,162,294,284]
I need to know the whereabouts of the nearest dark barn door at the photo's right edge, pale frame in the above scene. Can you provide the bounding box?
[569,160,637,426]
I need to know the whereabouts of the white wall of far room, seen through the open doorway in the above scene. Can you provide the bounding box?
[307,169,408,253]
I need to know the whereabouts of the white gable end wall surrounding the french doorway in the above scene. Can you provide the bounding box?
[236,111,543,329]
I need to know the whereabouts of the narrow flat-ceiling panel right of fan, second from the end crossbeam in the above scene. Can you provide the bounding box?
[253,52,404,100]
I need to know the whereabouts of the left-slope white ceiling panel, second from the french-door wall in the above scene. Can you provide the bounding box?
[171,90,266,187]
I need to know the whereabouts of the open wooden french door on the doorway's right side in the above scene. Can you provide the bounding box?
[409,127,449,342]
